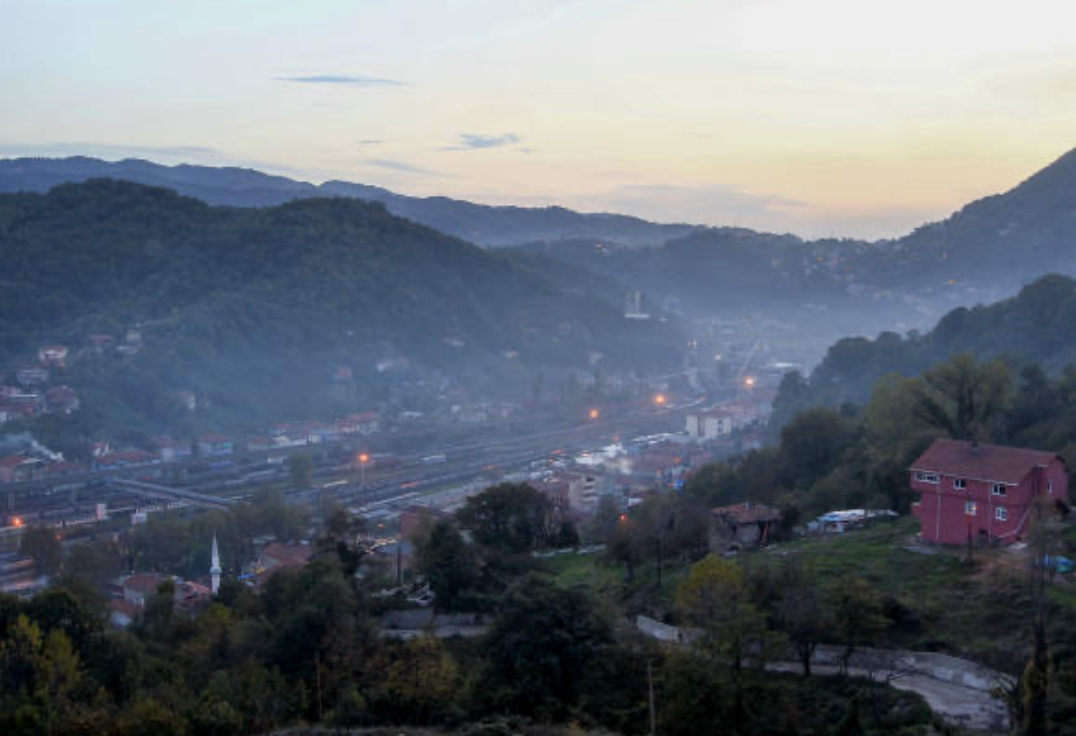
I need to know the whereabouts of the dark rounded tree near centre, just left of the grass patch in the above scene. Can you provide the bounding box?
[456,483,553,554]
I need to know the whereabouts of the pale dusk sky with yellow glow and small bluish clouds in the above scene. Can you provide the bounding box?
[0,0,1076,238]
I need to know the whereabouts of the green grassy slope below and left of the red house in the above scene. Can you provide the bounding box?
[547,519,1076,670]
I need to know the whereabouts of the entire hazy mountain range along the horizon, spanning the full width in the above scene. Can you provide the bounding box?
[6,151,1076,363]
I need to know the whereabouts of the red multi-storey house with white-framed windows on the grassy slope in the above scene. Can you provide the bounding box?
[909,439,1068,544]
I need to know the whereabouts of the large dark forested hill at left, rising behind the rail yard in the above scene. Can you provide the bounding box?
[0,180,682,434]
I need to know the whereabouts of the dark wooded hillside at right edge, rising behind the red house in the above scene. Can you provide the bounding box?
[777,274,1076,408]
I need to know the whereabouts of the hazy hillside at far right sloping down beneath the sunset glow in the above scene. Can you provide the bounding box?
[532,146,1076,355]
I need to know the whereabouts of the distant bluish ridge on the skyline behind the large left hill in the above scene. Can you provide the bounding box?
[0,156,695,246]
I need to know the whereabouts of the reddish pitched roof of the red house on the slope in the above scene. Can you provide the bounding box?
[909,439,1064,485]
